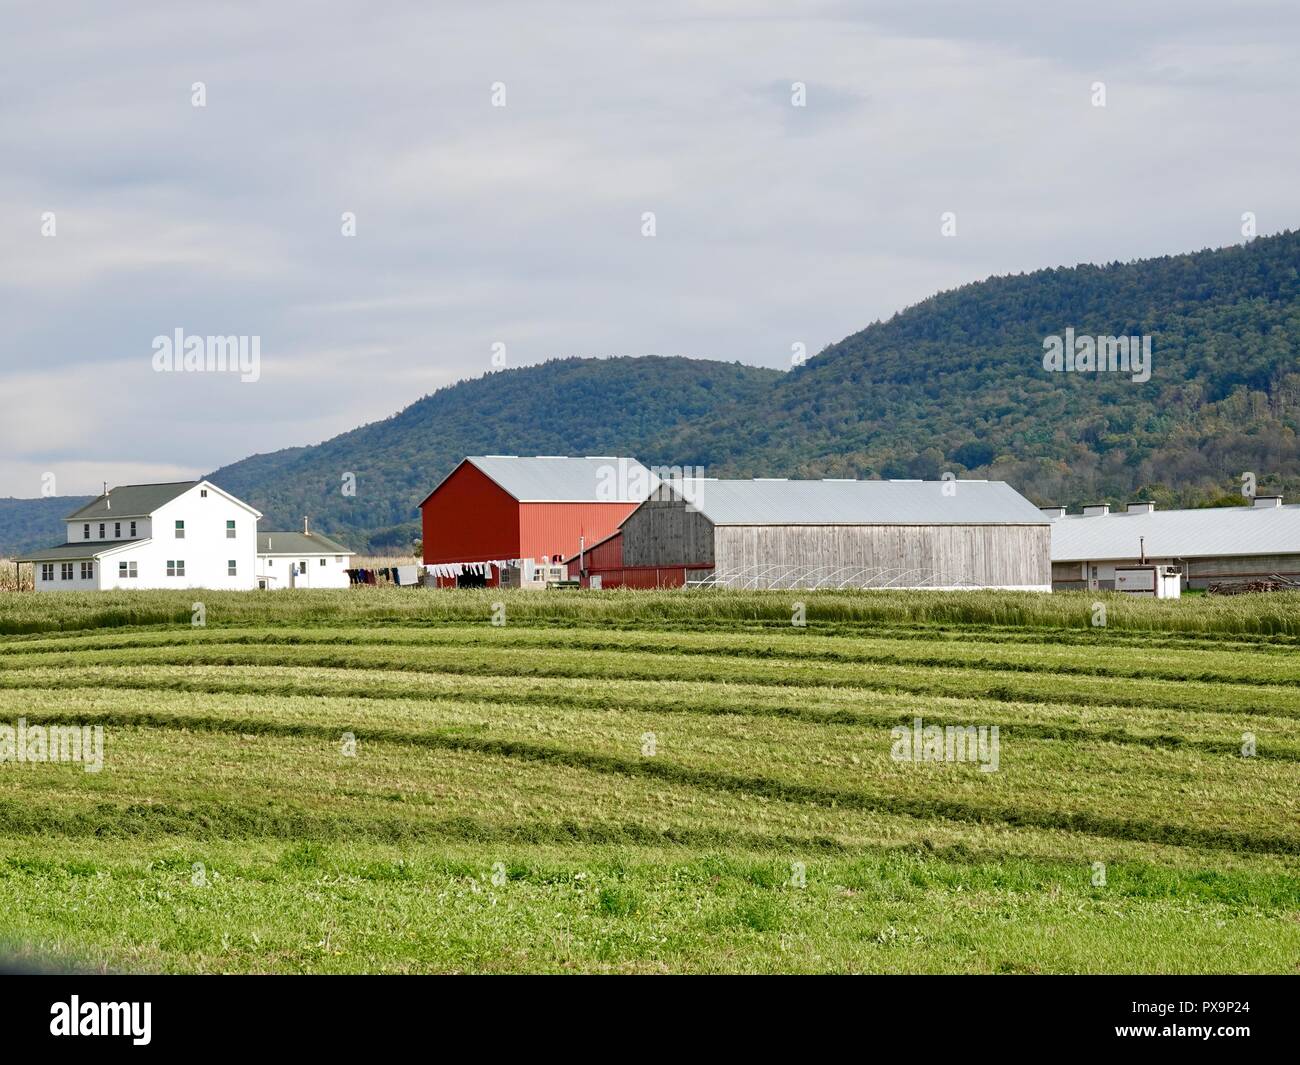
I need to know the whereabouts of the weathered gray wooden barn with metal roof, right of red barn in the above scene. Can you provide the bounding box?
[621,479,1052,592]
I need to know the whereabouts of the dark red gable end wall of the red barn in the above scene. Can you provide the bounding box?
[420,462,523,564]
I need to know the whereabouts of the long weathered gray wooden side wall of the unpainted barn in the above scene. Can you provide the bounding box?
[717,525,1052,586]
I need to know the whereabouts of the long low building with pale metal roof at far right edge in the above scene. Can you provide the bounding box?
[1043,495,1300,592]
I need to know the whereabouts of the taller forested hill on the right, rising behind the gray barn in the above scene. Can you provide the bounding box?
[684,226,1300,505]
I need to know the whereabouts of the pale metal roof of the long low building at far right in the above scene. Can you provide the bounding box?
[1052,503,1300,562]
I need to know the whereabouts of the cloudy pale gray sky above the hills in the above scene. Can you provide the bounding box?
[0,0,1300,497]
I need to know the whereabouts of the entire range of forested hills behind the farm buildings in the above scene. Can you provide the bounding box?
[10,233,1300,550]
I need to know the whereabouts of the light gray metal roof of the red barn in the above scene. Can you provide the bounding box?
[429,455,654,503]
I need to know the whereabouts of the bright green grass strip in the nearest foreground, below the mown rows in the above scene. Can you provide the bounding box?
[0,839,1300,973]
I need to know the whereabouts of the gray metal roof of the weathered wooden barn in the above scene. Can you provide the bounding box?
[668,479,1050,525]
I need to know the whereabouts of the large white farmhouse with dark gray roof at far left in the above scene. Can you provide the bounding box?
[17,481,261,592]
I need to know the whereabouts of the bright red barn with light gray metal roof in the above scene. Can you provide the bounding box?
[420,455,653,588]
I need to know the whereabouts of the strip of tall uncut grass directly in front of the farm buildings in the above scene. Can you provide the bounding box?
[0,588,1300,637]
